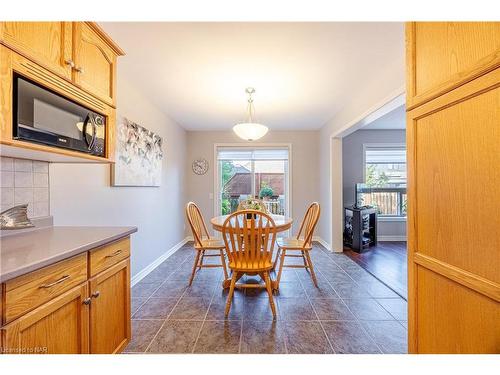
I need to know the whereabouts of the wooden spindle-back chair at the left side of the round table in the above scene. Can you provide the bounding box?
[186,202,228,286]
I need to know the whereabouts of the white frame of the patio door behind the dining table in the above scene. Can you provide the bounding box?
[213,142,293,222]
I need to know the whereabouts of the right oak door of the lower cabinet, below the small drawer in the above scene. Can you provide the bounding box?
[90,259,130,354]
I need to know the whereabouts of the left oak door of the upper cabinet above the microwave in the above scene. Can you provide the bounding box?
[0,22,73,80]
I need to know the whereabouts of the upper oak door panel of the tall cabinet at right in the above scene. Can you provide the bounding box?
[407,22,500,107]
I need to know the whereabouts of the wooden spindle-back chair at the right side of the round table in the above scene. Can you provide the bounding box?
[274,202,320,289]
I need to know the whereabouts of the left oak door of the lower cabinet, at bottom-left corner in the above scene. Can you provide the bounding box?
[2,283,89,354]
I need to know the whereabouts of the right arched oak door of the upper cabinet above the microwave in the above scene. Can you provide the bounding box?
[73,22,116,105]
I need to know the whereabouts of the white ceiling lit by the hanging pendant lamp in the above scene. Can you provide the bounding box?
[101,22,404,130]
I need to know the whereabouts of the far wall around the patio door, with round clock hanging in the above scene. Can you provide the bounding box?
[186,131,322,238]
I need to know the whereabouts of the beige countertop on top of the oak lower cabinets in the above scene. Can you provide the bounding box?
[0,226,137,283]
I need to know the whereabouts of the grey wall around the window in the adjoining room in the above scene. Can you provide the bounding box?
[342,130,406,240]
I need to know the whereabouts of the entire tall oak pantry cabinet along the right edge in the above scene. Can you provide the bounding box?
[406,22,500,353]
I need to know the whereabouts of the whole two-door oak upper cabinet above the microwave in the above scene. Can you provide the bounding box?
[0,22,124,107]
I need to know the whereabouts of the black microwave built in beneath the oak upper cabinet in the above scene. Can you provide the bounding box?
[13,74,106,157]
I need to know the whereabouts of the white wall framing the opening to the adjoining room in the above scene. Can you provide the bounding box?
[318,56,405,251]
